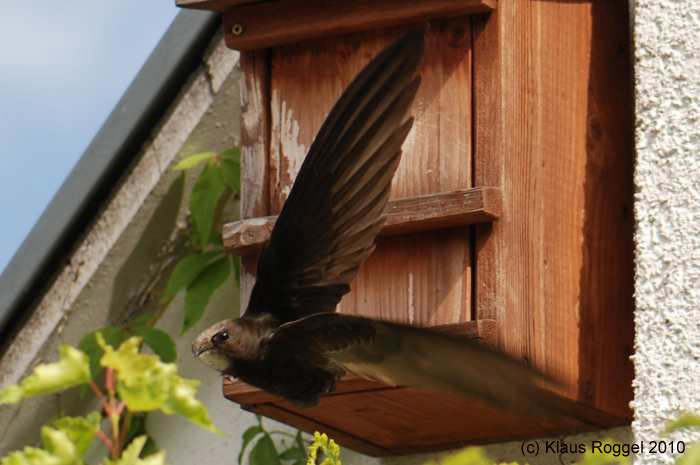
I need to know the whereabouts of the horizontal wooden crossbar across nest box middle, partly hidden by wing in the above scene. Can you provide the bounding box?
[223,187,501,256]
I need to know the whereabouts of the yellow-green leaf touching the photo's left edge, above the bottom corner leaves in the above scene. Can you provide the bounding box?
[0,344,90,404]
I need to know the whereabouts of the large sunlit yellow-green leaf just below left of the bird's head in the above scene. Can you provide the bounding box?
[98,335,218,432]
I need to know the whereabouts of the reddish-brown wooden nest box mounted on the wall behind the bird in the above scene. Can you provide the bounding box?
[178,0,633,455]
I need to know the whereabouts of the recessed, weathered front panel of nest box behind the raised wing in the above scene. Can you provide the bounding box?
[270,17,472,324]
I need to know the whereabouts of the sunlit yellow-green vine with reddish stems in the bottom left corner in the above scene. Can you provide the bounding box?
[0,332,219,465]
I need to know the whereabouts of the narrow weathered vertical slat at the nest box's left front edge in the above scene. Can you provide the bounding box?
[240,51,270,311]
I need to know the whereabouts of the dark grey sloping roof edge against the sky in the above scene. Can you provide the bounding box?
[0,11,219,341]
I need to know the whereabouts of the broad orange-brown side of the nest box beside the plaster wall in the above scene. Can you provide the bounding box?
[473,0,633,417]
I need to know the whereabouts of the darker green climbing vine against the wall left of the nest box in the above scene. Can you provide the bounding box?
[78,148,240,379]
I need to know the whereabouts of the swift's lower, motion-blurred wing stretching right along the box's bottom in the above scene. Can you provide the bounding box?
[267,313,565,417]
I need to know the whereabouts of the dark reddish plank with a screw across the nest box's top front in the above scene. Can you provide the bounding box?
[224,0,496,50]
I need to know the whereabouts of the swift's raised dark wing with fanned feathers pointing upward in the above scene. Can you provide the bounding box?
[246,30,424,321]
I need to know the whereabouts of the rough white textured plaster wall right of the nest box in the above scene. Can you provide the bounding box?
[632,0,700,464]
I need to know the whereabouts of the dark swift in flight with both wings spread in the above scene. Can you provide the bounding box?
[192,30,564,410]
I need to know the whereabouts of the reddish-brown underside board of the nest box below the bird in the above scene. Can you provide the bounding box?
[243,388,621,456]
